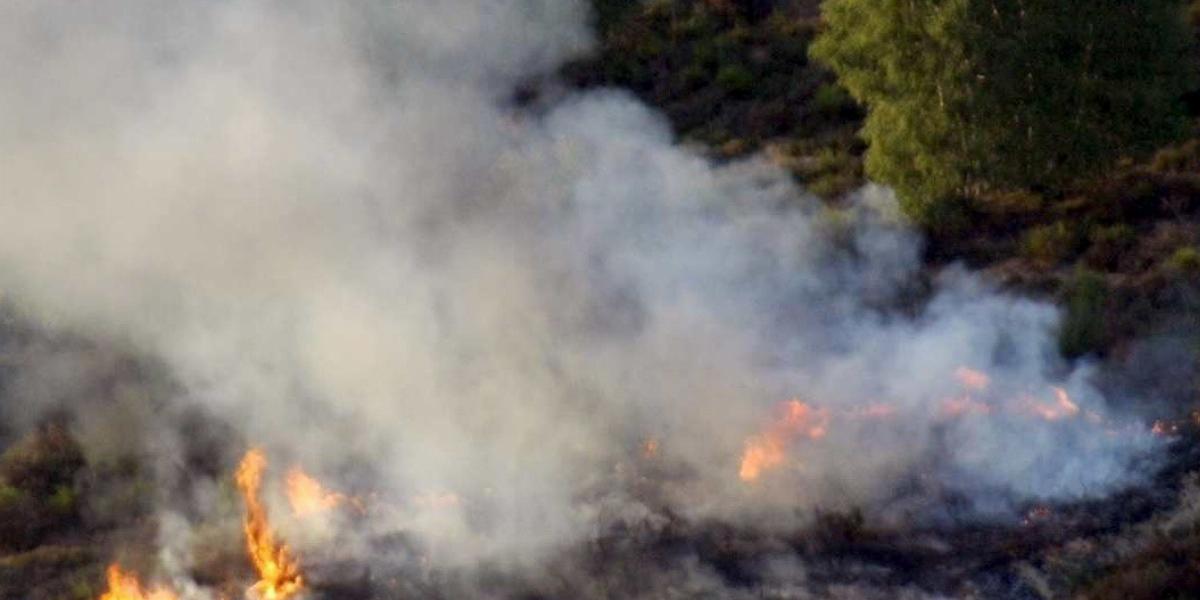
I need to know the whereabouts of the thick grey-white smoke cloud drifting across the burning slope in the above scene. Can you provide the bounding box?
[0,0,1152,590]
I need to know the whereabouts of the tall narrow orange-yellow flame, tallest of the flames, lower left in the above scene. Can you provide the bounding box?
[235,449,304,600]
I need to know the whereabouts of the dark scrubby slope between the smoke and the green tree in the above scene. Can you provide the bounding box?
[564,0,865,192]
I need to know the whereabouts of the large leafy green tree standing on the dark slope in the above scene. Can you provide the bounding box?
[811,0,1193,220]
